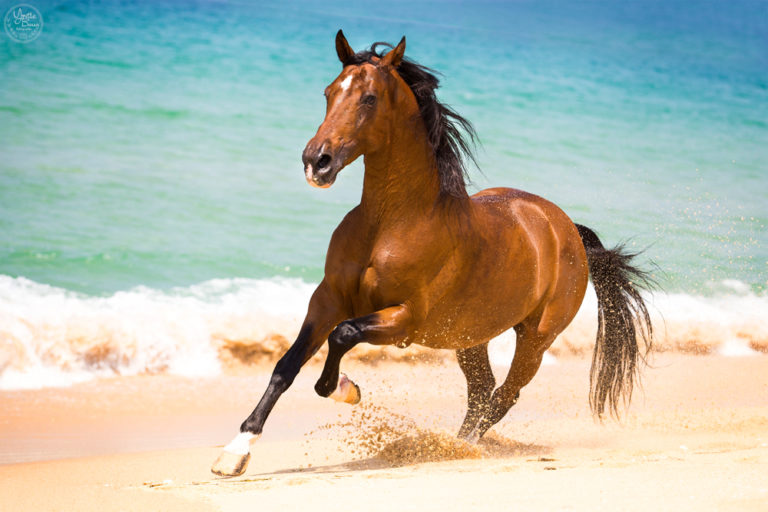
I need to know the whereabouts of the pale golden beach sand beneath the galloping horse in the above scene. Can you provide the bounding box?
[0,354,768,512]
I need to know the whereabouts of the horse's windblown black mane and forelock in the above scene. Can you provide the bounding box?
[344,42,477,197]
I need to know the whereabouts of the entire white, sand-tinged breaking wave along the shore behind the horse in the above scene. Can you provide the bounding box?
[0,275,768,389]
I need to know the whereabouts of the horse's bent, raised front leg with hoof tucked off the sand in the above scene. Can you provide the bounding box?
[315,305,412,403]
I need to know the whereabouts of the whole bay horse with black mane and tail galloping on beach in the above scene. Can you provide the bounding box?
[211,31,652,476]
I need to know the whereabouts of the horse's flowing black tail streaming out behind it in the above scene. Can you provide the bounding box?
[576,224,653,417]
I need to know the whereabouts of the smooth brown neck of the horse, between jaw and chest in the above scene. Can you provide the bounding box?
[360,117,450,228]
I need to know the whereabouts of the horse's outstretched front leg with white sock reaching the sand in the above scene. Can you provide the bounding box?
[211,282,343,476]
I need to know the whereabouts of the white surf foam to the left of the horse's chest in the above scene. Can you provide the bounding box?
[0,276,314,389]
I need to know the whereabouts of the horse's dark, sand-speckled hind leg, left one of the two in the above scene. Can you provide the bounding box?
[456,343,496,439]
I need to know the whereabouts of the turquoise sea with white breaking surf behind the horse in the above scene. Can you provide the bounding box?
[0,0,768,389]
